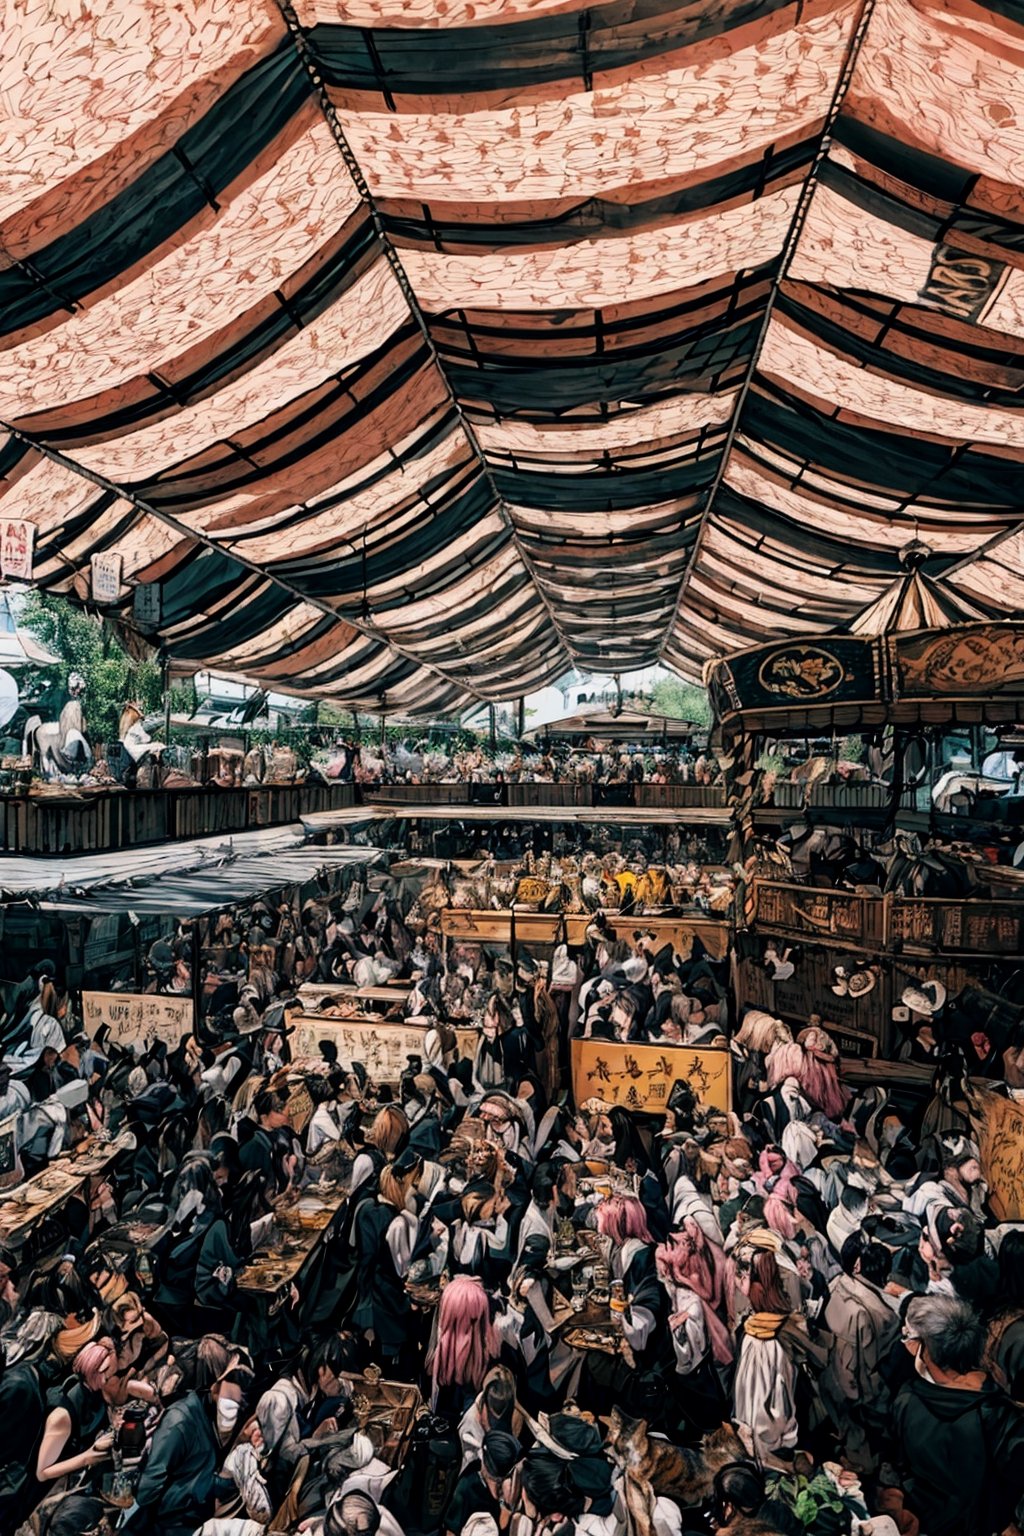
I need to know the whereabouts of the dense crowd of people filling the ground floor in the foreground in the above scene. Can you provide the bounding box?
[0,872,1024,1536]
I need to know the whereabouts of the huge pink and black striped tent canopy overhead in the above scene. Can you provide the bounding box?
[0,0,1024,716]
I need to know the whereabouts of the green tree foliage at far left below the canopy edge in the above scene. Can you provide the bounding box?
[18,591,163,742]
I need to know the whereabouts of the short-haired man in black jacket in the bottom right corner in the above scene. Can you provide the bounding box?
[892,1296,1024,1536]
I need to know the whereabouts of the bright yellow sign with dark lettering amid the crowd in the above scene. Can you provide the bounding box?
[573,1040,732,1115]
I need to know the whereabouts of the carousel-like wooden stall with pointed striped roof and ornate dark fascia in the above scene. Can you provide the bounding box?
[708,547,1024,1054]
